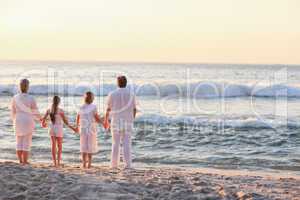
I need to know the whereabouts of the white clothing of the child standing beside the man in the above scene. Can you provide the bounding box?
[78,104,98,153]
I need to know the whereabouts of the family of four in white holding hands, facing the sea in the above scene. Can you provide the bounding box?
[11,76,137,169]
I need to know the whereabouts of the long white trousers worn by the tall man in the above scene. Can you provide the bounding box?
[111,130,132,168]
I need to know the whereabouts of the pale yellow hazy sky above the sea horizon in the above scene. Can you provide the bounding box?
[0,0,300,64]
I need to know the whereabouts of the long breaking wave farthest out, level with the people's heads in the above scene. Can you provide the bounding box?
[0,82,300,98]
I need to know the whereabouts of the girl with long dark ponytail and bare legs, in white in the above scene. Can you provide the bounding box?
[42,96,76,167]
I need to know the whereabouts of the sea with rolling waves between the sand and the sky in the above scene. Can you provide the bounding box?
[0,61,300,175]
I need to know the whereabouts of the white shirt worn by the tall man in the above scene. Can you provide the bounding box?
[107,88,136,123]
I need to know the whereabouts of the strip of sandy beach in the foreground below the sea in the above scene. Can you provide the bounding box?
[0,161,300,200]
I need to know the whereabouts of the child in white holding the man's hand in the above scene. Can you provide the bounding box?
[76,92,104,168]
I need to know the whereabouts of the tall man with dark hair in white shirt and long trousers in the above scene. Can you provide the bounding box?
[105,76,136,168]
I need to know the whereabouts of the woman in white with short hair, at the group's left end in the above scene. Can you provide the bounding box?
[11,79,41,165]
